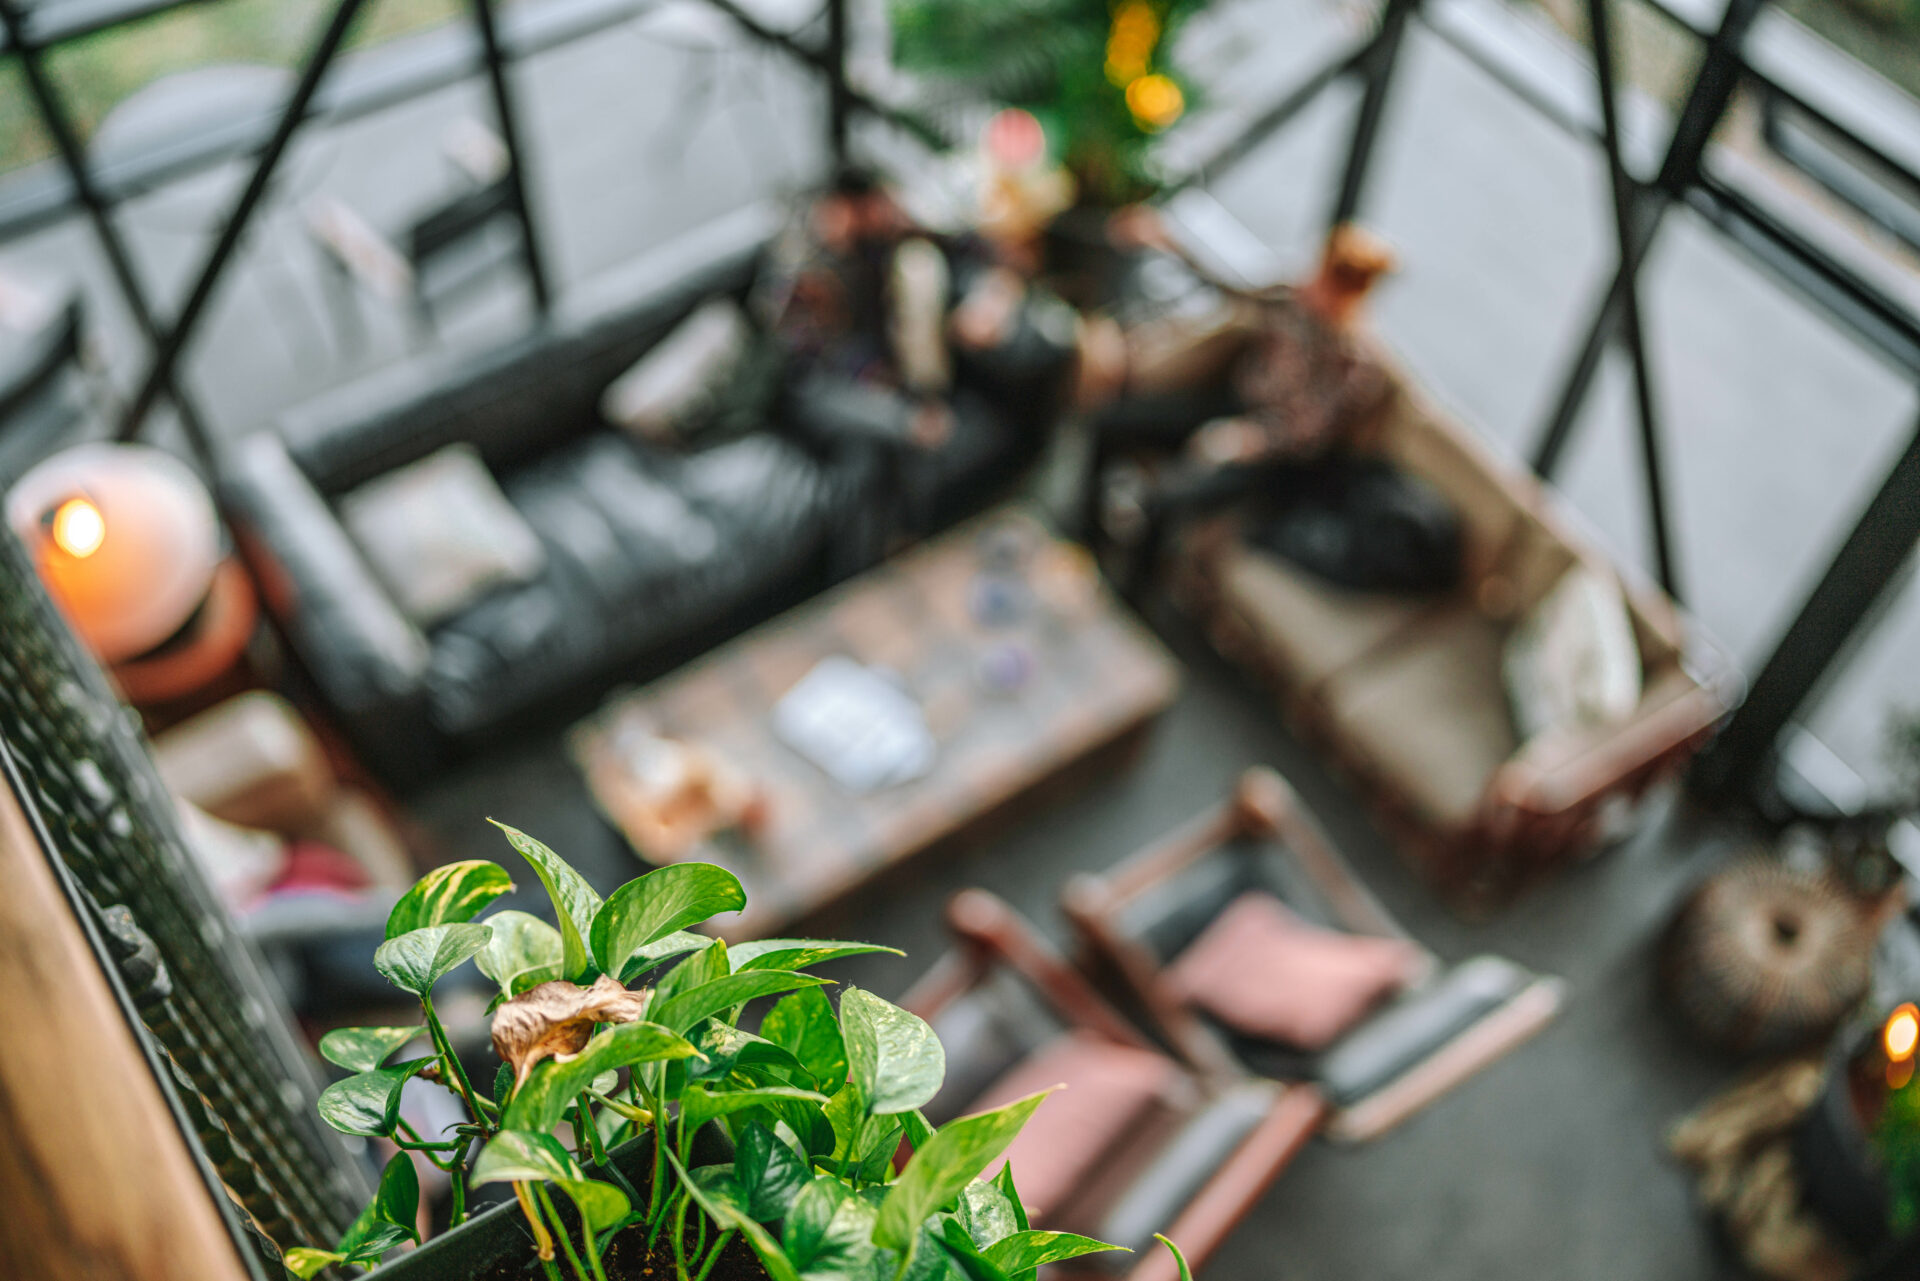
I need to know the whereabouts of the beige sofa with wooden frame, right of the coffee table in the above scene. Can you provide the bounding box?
[1175,353,1740,910]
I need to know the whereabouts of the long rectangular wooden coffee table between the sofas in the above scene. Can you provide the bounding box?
[568,509,1179,939]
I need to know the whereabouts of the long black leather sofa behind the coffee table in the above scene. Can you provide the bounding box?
[221,205,1067,786]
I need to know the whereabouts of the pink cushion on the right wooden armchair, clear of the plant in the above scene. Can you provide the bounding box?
[1164,889,1421,1051]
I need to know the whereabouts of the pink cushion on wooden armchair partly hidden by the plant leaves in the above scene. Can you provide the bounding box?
[968,1031,1185,1225]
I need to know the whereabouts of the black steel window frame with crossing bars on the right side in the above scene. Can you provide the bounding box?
[1175,0,1920,799]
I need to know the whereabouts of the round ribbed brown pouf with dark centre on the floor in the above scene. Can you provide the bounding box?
[1661,855,1874,1052]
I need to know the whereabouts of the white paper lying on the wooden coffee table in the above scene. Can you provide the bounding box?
[774,655,933,793]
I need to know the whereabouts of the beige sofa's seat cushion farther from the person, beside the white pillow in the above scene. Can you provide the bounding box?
[1323,607,1517,828]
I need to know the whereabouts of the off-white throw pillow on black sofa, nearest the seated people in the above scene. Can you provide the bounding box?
[599,298,753,444]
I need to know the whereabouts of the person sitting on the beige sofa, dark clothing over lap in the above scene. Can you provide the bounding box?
[1096,211,1461,592]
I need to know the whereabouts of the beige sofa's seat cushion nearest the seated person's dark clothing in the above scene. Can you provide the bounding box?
[1219,544,1428,689]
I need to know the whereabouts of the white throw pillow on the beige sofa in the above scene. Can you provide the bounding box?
[1501,565,1642,739]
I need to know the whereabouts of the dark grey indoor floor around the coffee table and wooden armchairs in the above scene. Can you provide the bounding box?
[413,614,1743,1281]
